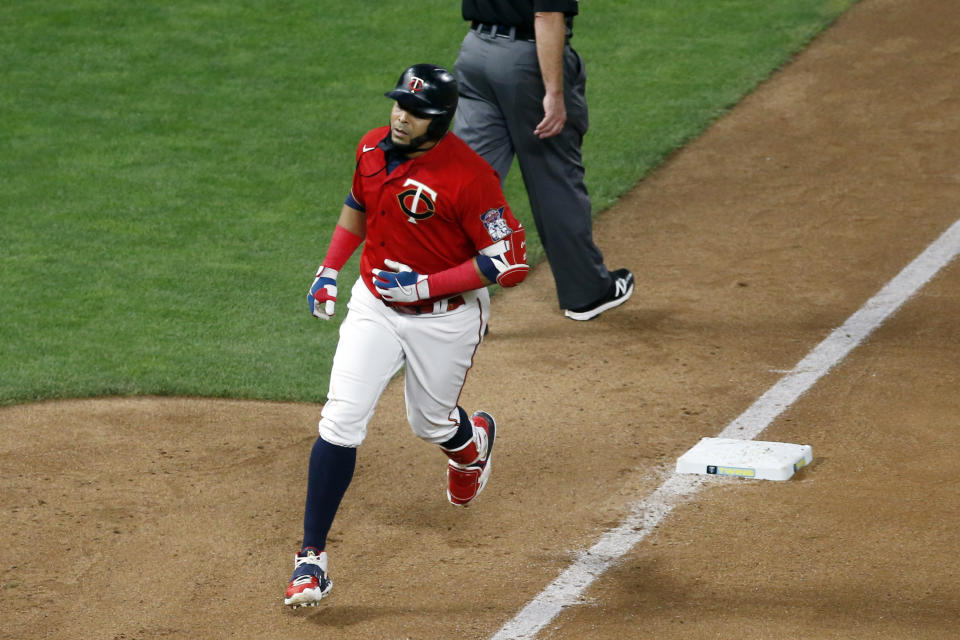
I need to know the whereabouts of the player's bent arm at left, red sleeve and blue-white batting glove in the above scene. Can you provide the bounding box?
[307,200,366,320]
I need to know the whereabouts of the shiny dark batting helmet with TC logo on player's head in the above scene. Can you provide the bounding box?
[384,63,459,140]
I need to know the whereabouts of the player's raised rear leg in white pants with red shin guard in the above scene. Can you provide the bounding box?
[404,289,496,505]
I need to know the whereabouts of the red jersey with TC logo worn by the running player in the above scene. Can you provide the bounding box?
[351,127,521,297]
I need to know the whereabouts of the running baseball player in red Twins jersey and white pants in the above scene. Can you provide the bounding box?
[284,64,529,607]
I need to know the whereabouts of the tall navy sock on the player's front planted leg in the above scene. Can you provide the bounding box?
[303,438,357,551]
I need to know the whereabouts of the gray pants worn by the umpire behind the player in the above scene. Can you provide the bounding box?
[453,31,612,309]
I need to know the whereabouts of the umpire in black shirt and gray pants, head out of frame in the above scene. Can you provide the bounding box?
[453,0,633,320]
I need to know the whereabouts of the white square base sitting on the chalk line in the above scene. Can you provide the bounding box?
[677,438,813,480]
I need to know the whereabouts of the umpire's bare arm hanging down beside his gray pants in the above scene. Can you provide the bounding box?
[533,11,567,138]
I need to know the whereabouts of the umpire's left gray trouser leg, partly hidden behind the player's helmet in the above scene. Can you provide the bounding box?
[452,31,513,184]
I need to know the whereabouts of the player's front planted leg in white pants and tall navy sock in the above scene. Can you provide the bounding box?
[284,283,403,607]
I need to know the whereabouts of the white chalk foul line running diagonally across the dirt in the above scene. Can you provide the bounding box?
[491,220,960,640]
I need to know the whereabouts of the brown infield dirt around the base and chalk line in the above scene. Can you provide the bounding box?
[0,0,960,640]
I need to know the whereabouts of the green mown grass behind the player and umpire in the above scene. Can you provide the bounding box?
[0,0,853,404]
